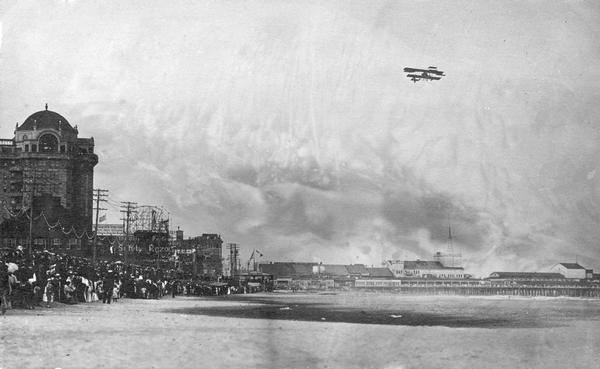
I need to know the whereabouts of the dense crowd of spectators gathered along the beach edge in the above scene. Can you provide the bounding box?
[0,246,270,315]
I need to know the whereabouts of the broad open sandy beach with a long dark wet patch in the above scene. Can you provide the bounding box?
[0,293,600,369]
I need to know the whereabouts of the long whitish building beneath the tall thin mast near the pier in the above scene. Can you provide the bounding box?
[386,260,467,279]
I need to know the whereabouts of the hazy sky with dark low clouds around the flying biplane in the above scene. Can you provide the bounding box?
[0,0,600,274]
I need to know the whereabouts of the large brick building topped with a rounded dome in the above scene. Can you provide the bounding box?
[0,105,98,253]
